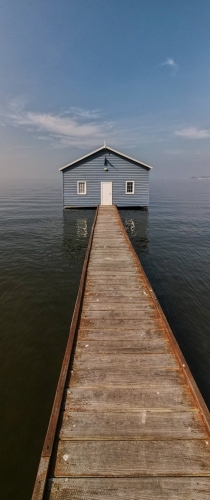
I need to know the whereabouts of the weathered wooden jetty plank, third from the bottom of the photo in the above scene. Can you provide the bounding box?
[59,409,208,441]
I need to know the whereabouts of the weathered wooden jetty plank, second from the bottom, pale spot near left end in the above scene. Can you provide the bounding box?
[55,439,210,477]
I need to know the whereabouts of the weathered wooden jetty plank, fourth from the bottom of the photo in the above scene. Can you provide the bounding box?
[64,384,195,413]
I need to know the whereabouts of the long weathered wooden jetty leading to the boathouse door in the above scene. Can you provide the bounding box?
[32,206,210,500]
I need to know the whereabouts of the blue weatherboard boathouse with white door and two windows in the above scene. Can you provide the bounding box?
[59,145,152,208]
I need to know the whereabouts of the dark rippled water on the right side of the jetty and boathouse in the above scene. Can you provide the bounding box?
[121,179,210,408]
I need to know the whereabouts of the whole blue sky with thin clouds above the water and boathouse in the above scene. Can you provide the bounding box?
[0,0,210,178]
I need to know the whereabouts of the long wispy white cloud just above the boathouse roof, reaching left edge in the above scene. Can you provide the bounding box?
[1,100,166,148]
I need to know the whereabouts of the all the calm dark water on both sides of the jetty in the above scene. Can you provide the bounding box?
[0,180,210,500]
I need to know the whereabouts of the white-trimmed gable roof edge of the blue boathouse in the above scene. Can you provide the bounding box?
[59,146,153,171]
